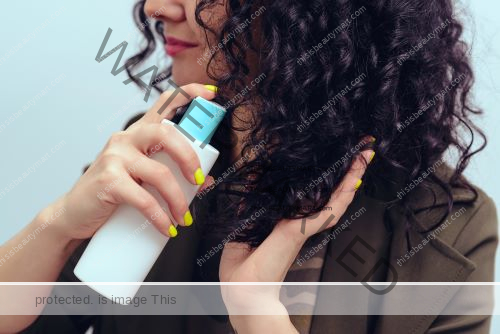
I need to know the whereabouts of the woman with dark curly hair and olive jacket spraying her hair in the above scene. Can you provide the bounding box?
[0,0,497,333]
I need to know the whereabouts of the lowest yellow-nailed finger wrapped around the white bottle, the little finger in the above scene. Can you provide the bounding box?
[112,175,177,237]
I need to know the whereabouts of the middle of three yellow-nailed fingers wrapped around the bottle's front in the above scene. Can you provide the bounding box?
[130,157,193,226]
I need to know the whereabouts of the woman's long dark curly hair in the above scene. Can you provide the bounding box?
[127,0,486,246]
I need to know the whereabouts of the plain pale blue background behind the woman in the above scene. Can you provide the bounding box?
[0,0,500,333]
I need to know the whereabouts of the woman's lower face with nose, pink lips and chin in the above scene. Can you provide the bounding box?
[144,0,224,85]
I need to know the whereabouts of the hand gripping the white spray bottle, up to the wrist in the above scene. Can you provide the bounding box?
[53,84,215,239]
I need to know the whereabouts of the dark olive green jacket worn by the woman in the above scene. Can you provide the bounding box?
[22,166,498,334]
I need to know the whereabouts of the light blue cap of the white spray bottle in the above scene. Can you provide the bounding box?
[179,96,226,144]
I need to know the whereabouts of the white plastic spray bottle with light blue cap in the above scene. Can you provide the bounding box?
[74,97,225,299]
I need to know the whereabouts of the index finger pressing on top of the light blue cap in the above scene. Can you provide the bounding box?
[140,83,215,123]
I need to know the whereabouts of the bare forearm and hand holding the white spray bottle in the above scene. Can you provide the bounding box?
[0,84,215,333]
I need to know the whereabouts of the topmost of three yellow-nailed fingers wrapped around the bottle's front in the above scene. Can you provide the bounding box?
[131,124,205,185]
